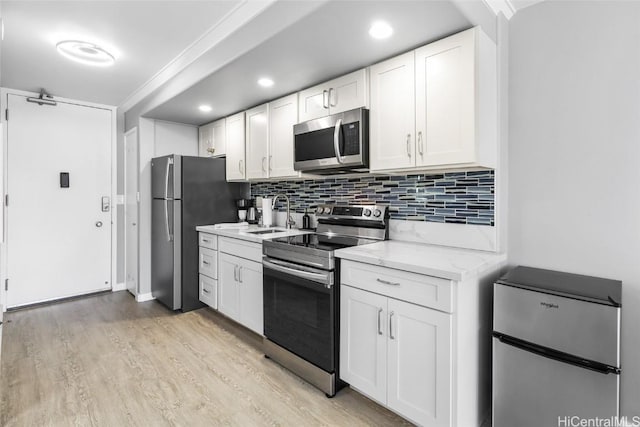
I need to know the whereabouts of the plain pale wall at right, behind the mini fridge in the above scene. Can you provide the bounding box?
[508,1,640,416]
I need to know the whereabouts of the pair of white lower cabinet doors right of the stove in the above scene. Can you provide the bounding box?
[340,284,452,426]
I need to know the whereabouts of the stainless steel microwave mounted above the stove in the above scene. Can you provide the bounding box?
[293,108,369,174]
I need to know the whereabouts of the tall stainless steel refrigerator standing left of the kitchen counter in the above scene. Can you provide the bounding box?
[151,154,250,311]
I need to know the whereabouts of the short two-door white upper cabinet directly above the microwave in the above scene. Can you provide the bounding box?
[298,68,369,122]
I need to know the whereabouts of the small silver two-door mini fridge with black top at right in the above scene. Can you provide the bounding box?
[492,267,622,427]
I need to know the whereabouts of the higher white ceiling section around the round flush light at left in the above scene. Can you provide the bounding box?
[0,0,242,105]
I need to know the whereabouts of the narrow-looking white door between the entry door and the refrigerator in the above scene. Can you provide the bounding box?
[124,128,138,296]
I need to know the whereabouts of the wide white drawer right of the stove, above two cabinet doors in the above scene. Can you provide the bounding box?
[340,260,453,313]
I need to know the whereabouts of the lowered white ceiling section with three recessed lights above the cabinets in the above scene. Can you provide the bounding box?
[145,0,471,125]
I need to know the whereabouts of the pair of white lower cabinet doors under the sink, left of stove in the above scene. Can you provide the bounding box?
[218,252,264,335]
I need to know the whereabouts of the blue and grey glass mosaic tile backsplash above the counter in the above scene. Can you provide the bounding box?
[251,170,495,226]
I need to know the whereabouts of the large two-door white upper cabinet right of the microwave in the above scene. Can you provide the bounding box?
[370,27,497,171]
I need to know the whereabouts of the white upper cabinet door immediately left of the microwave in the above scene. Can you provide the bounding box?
[268,93,300,178]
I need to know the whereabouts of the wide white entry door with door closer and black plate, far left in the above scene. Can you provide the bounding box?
[6,94,112,307]
